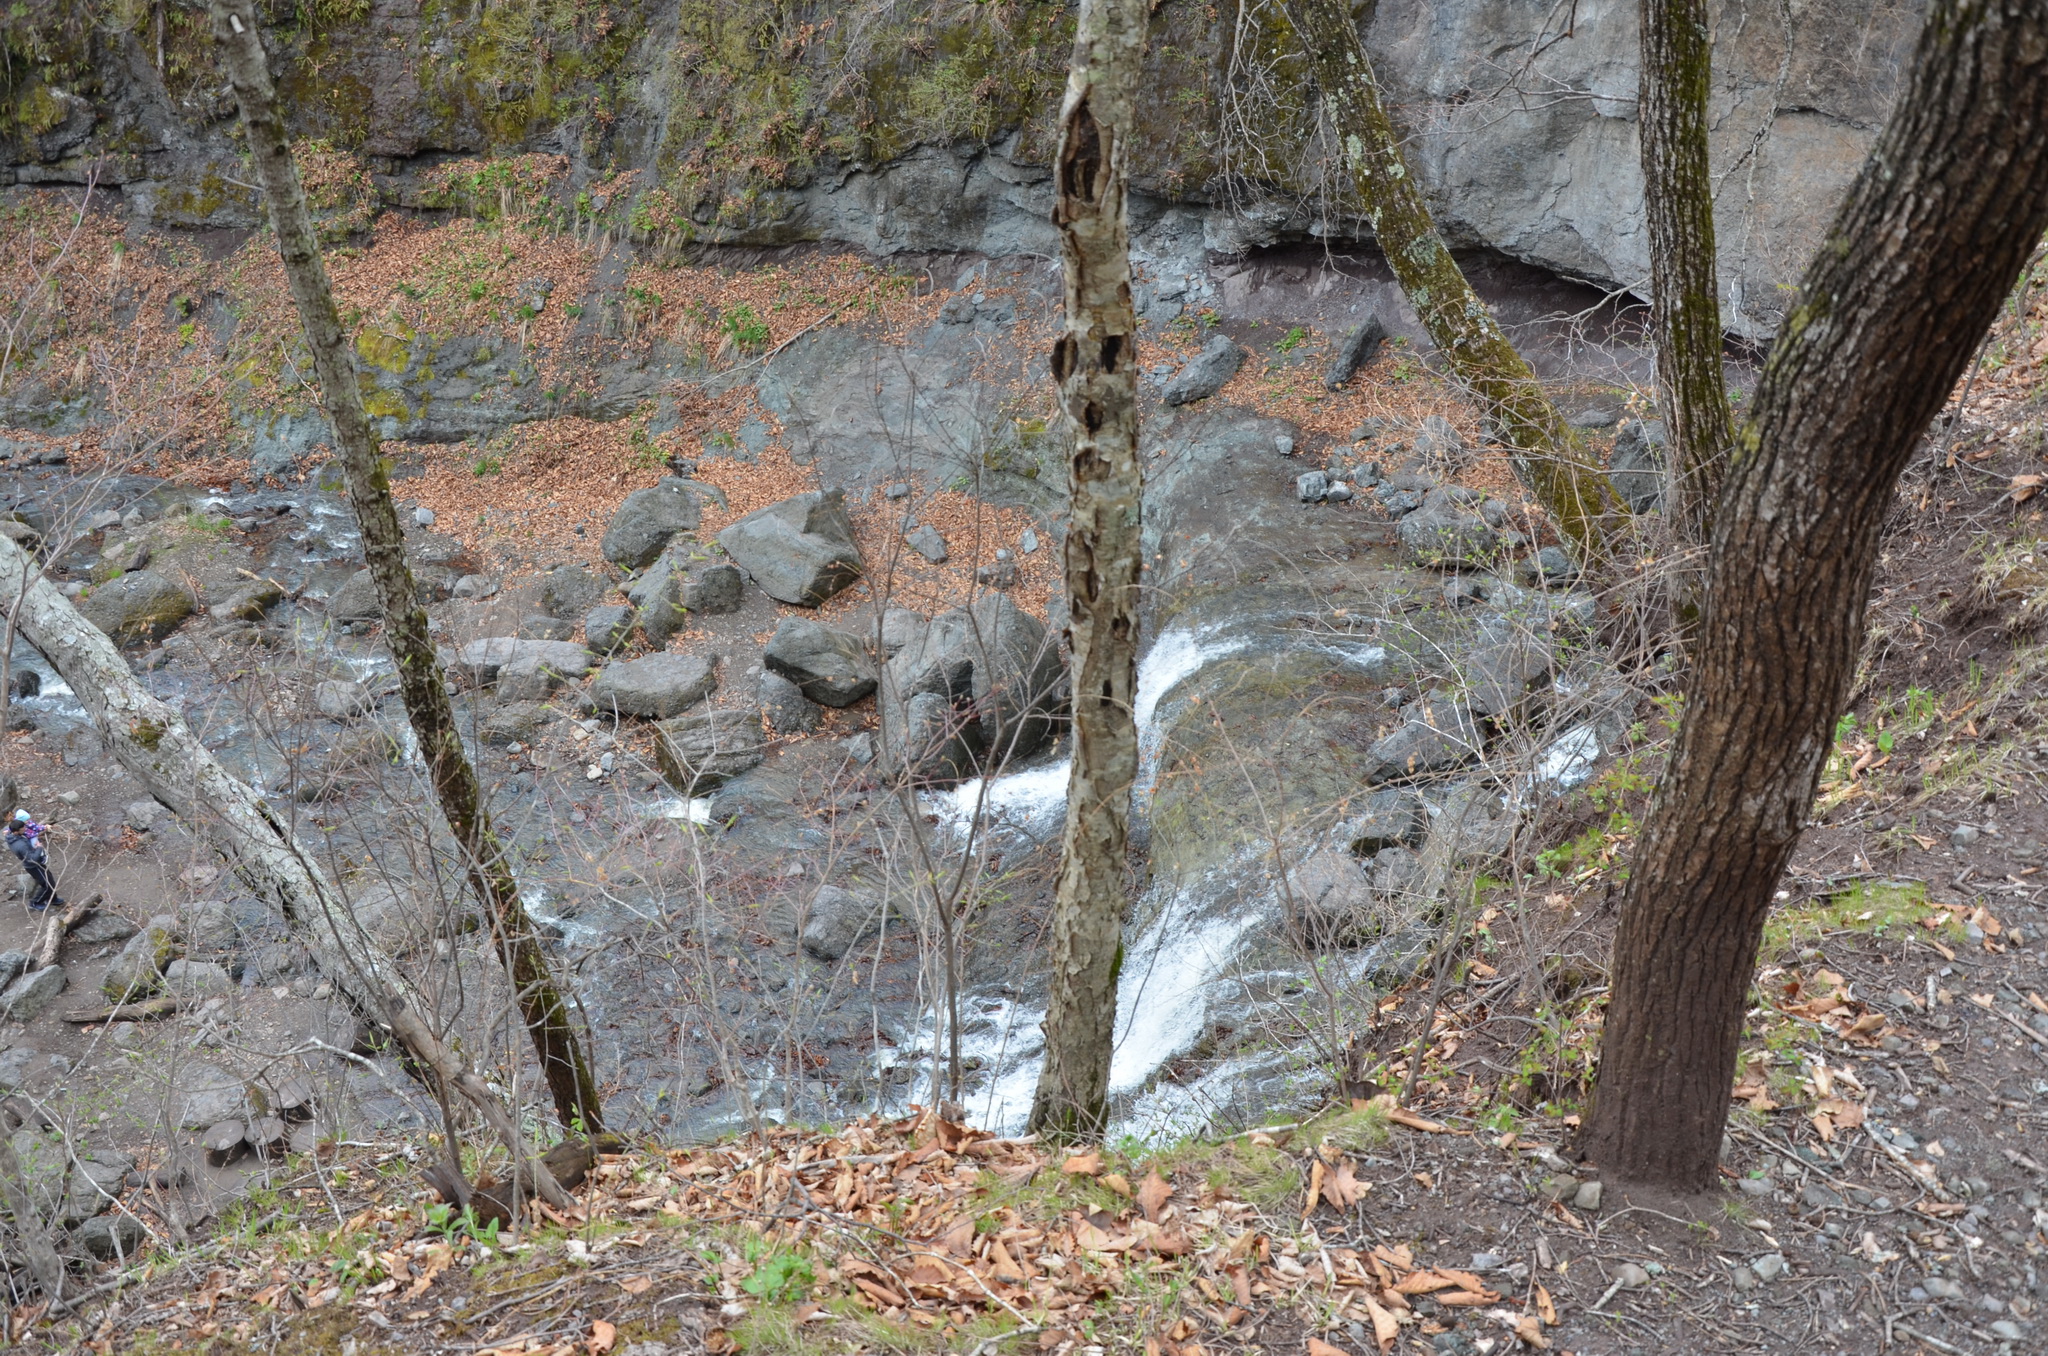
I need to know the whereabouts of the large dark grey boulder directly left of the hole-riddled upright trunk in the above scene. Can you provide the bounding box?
[883,594,1065,780]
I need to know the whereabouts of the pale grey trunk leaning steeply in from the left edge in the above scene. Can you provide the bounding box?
[0,537,569,1204]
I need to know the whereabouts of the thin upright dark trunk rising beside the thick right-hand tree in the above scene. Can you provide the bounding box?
[1636,0,1735,545]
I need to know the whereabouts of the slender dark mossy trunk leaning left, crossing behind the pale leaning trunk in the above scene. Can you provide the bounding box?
[211,0,604,1135]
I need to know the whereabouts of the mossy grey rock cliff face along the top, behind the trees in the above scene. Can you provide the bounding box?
[0,0,1925,336]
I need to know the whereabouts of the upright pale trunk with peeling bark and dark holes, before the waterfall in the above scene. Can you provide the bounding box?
[1030,0,1147,1137]
